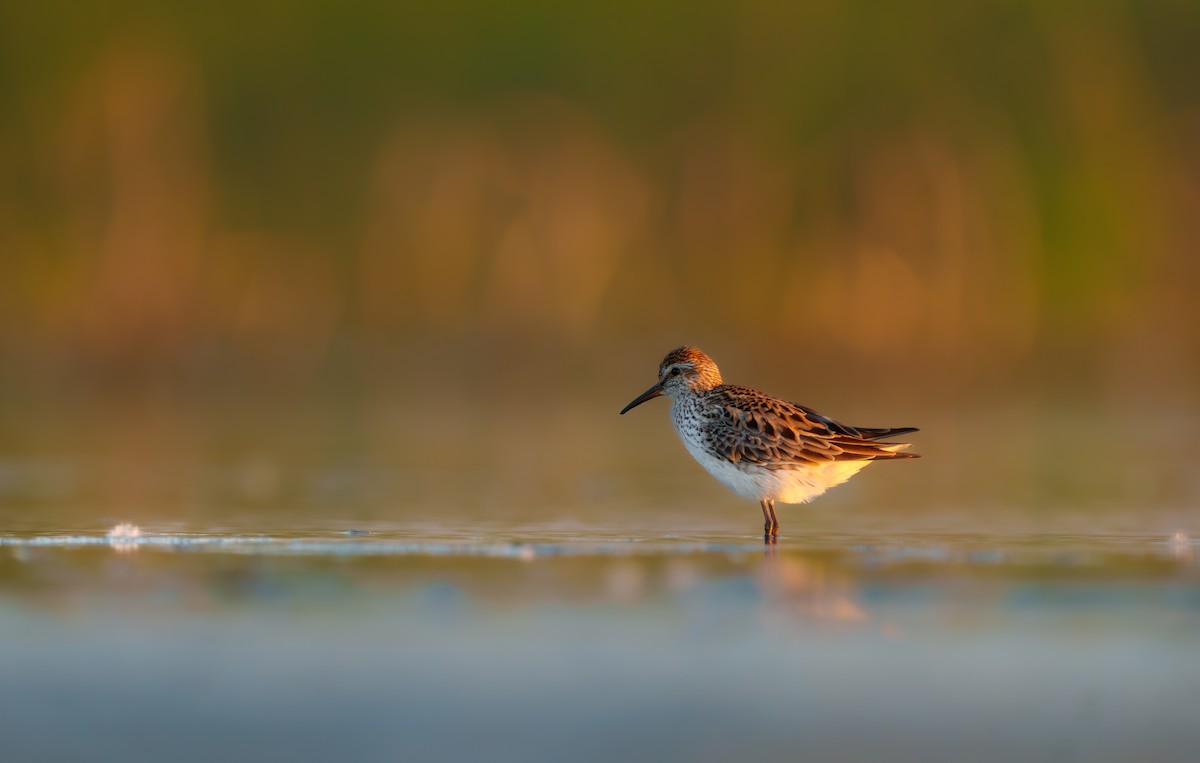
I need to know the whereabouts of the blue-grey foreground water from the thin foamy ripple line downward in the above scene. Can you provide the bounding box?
[0,522,1200,761]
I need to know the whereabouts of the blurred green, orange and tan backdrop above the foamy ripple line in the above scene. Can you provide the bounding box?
[0,0,1200,530]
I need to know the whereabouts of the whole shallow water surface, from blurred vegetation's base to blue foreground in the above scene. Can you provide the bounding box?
[0,391,1200,762]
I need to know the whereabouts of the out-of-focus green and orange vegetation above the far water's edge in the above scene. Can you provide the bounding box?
[0,0,1200,396]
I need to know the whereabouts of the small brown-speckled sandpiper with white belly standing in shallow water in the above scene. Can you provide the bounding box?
[620,346,919,542]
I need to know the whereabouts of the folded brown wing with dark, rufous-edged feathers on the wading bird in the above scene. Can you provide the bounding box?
[703,385,914,469]
